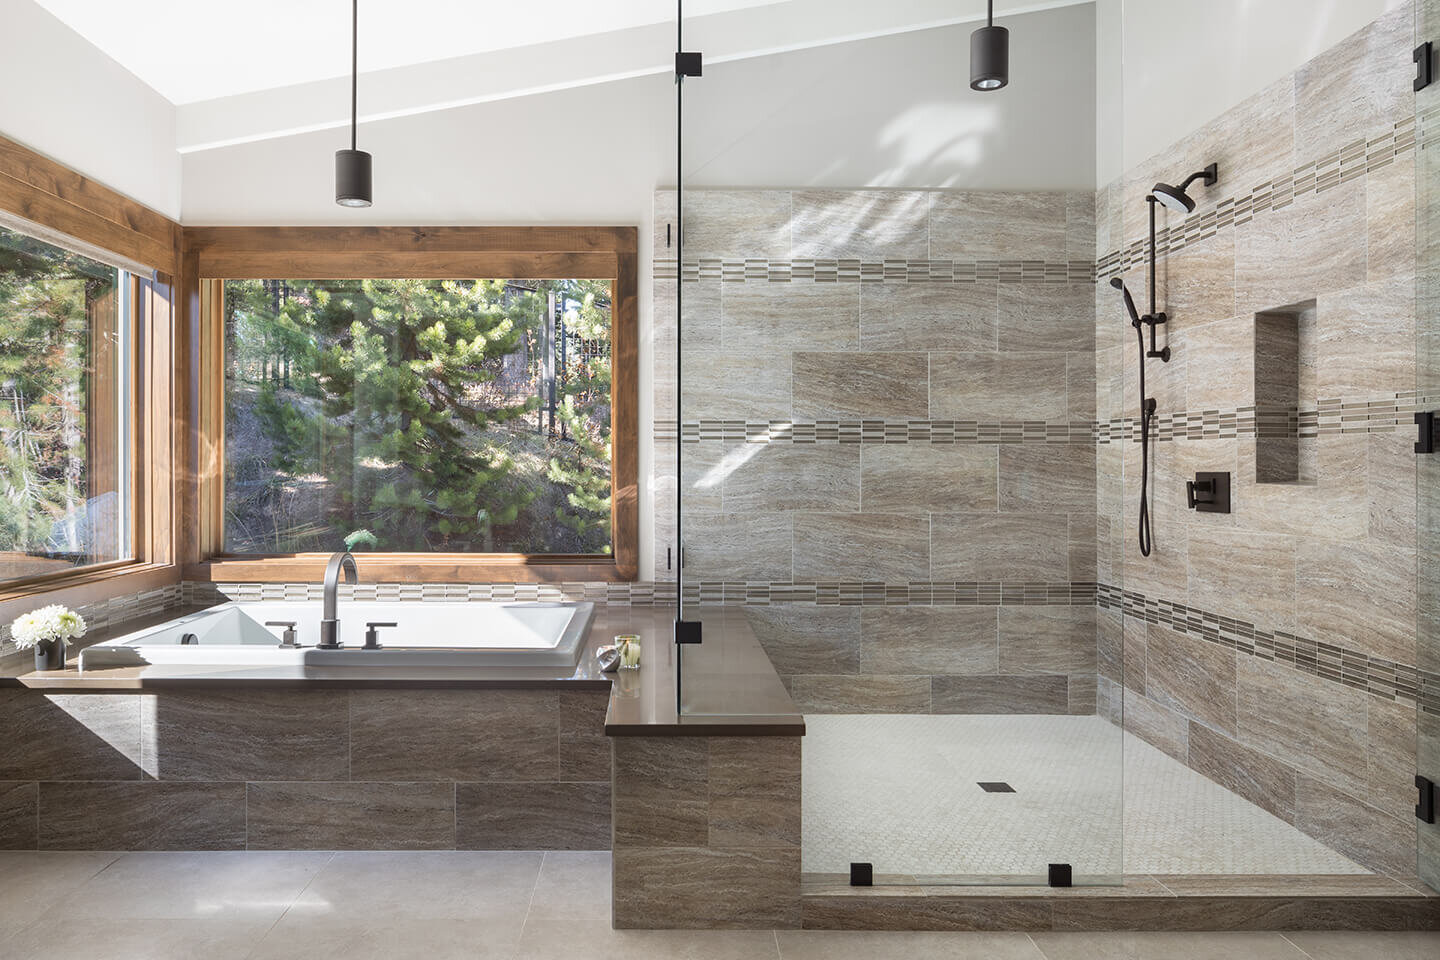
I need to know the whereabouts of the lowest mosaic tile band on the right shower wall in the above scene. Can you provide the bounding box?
[1096,583,1440,715]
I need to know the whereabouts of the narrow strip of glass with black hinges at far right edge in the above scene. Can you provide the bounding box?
[1416,0,1440,889]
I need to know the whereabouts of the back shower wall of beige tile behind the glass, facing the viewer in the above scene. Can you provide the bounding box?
[654,190,1097,714]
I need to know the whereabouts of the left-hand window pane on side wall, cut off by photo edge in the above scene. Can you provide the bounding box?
[0,229,135,581]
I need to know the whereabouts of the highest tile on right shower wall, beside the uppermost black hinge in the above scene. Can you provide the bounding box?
[1295,4,1414,160]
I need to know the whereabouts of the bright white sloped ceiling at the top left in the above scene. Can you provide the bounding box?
[36,0,789,105]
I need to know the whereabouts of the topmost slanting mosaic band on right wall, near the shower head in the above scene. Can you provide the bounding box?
[1094,111,1416,281]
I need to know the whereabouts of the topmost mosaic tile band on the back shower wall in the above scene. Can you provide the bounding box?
[654,258,1096,284]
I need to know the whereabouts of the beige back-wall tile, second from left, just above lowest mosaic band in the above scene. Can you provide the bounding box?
[793,514,930,583]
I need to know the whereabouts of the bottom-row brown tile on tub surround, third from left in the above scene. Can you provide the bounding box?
[243,782,455,851]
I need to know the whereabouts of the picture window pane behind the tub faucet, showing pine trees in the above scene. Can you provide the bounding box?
[222,279,613,556]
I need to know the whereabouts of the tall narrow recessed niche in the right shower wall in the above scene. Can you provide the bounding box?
[1254,299,1316,484]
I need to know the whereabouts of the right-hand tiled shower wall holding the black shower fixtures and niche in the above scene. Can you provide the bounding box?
[1096,4,1437,875]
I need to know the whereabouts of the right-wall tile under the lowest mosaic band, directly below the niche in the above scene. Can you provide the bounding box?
[1236,656,1367,796]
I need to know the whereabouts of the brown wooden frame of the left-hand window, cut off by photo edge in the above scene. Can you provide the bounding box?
[0,137,186,620]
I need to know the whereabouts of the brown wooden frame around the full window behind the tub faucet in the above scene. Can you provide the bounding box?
[180,226,639,583]
